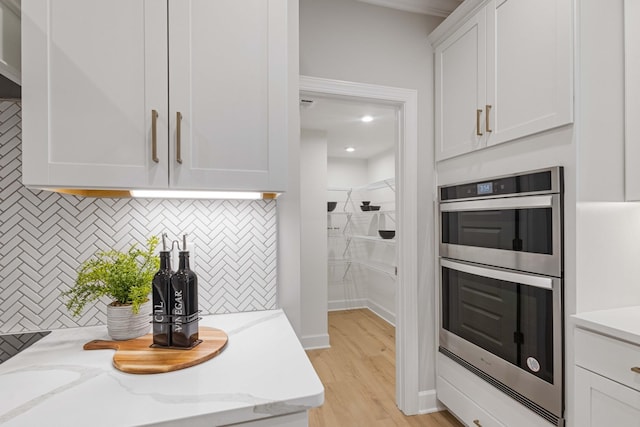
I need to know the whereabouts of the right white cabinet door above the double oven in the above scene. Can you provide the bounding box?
[486,0,573,146]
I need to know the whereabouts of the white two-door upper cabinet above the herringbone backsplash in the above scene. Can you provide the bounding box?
[22,0,287,191]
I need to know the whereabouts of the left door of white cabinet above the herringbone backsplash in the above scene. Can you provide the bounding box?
[22,0,168,188]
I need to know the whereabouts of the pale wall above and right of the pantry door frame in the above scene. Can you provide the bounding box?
[300,0,442,396]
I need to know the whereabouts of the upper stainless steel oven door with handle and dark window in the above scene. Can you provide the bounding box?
[440,194,562,277]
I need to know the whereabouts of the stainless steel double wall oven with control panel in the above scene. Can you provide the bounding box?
[439,167,564,425]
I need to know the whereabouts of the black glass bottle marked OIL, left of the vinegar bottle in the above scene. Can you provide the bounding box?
[152,233,173,347]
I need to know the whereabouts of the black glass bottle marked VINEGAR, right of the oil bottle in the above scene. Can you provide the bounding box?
[170,235,200,348]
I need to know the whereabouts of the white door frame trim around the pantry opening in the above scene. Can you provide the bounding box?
[300,76,420,415]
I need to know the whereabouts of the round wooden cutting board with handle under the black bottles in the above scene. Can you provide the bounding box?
[84,327,229,374]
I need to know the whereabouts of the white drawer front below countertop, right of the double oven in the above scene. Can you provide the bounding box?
[575,328,640,391]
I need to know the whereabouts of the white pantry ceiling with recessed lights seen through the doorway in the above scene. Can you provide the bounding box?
[300,94,397,159]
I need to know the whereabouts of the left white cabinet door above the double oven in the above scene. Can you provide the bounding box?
[435,9,486,160]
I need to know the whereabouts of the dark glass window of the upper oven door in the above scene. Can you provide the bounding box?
[442,208,553,255]
